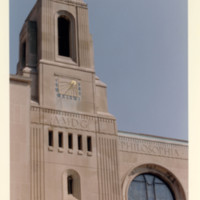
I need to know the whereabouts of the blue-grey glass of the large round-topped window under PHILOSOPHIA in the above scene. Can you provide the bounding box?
[128,174,175,200]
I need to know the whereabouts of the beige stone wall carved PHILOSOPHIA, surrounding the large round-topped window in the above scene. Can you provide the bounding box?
[118,133,188,200]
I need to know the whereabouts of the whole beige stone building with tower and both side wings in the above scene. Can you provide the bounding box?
[10,0,188,200]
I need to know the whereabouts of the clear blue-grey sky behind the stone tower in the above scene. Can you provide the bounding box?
[10,0,188,139]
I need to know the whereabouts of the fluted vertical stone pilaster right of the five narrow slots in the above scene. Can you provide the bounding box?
[97,134,120,200]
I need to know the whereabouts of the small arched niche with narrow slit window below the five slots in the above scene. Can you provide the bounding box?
[62,169,81,200]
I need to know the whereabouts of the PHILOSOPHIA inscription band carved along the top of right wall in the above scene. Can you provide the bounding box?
[119,137,187,159]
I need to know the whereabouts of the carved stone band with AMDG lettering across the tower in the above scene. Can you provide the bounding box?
[31,105,116,134]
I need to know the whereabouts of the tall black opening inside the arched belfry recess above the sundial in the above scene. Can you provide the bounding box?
[58,16,70,57]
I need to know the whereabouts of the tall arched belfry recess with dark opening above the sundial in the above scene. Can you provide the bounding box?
[55,10,77,61]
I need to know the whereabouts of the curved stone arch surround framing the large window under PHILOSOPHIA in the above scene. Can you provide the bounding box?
[121,163,186,200]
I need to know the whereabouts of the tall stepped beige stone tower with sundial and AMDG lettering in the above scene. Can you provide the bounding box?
[11,0,120,200]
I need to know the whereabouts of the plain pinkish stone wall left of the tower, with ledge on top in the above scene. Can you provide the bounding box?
[10,76,30,200]
